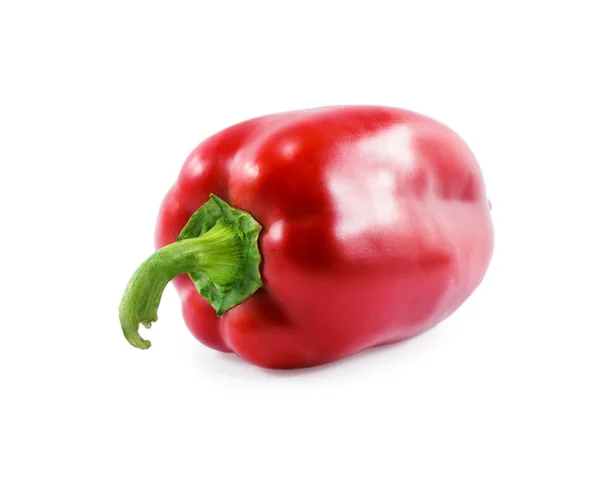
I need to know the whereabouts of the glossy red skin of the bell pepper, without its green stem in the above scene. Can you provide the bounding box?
[156,106,493,368]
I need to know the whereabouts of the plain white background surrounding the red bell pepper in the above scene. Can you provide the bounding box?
[0,0,600,503]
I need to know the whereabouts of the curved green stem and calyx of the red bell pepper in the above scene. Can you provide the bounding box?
[119,194,262,349]
